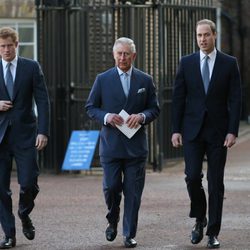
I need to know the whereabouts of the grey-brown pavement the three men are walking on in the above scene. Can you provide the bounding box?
[0,123,250,250]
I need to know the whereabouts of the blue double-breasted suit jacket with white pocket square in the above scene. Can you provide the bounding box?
[85,67,159,158]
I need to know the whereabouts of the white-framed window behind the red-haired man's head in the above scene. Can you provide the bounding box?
[0,19,37,60]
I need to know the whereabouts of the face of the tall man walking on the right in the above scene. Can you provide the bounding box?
[196,24,216,54]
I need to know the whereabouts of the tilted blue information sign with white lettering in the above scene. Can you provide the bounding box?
[62,130,99,170]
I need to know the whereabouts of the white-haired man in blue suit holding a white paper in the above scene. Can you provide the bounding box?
[86,37,159,248]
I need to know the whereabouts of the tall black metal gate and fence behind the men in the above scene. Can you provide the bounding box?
[36,0,216,172]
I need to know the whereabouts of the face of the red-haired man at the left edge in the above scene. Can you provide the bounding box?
[0,37,18,62]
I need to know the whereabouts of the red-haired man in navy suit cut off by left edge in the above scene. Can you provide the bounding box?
[0,27,49,249]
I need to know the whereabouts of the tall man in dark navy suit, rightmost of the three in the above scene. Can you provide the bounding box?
[172,19,241,248]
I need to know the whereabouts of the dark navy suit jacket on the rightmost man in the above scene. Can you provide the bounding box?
[172,51,241,140]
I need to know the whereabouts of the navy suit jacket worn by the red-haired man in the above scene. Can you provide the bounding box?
[0,57,49,148]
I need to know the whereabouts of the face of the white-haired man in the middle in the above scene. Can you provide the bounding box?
[113,44,136,72]
